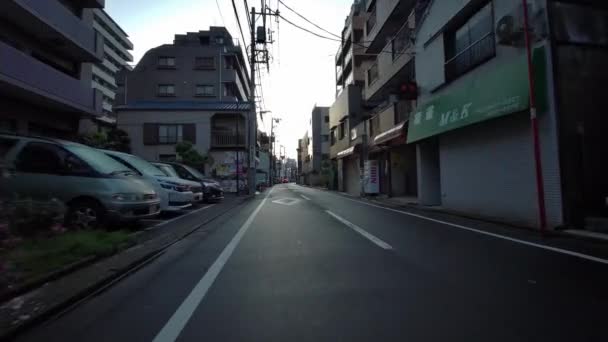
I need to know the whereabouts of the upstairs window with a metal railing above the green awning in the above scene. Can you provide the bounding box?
[444,2,496,81]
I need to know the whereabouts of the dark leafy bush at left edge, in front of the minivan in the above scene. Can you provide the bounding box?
[0,198,66,237]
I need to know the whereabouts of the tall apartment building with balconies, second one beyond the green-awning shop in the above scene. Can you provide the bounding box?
[329,1,374,195]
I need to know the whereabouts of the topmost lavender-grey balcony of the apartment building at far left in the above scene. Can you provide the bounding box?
[0,0,103,63]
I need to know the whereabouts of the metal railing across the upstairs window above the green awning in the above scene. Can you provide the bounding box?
[445,32,496,81]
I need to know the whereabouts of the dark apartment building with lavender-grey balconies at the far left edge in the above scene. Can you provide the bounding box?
[0,0,105,138]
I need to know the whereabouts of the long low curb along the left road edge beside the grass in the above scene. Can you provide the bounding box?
[0,195,255,341]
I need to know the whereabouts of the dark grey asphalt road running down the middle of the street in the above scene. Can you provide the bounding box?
[14,185,608,342]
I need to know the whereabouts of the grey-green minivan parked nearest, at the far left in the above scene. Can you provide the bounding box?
[0,134,160,229]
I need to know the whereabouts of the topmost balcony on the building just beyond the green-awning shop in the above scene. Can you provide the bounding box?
[365,0,416,53]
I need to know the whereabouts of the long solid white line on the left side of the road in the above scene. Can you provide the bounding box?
[153,190,272,342]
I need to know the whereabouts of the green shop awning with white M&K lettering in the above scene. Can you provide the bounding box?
[407,48,546,143]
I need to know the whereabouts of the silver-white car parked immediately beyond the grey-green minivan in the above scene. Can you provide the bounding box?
[103,150,202,211]
